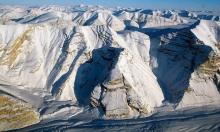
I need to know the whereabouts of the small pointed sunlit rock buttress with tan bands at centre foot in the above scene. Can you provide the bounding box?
[101,67,131,118]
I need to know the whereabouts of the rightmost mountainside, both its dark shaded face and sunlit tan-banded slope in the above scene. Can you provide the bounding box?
[150,21,220,108]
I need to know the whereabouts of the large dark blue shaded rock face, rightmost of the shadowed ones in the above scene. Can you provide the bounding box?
[151,30,211,103]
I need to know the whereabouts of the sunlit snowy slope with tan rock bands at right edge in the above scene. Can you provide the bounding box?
[177,20,220,106]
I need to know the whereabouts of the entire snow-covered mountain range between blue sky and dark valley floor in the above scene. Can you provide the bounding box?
[0,5,220,130]
